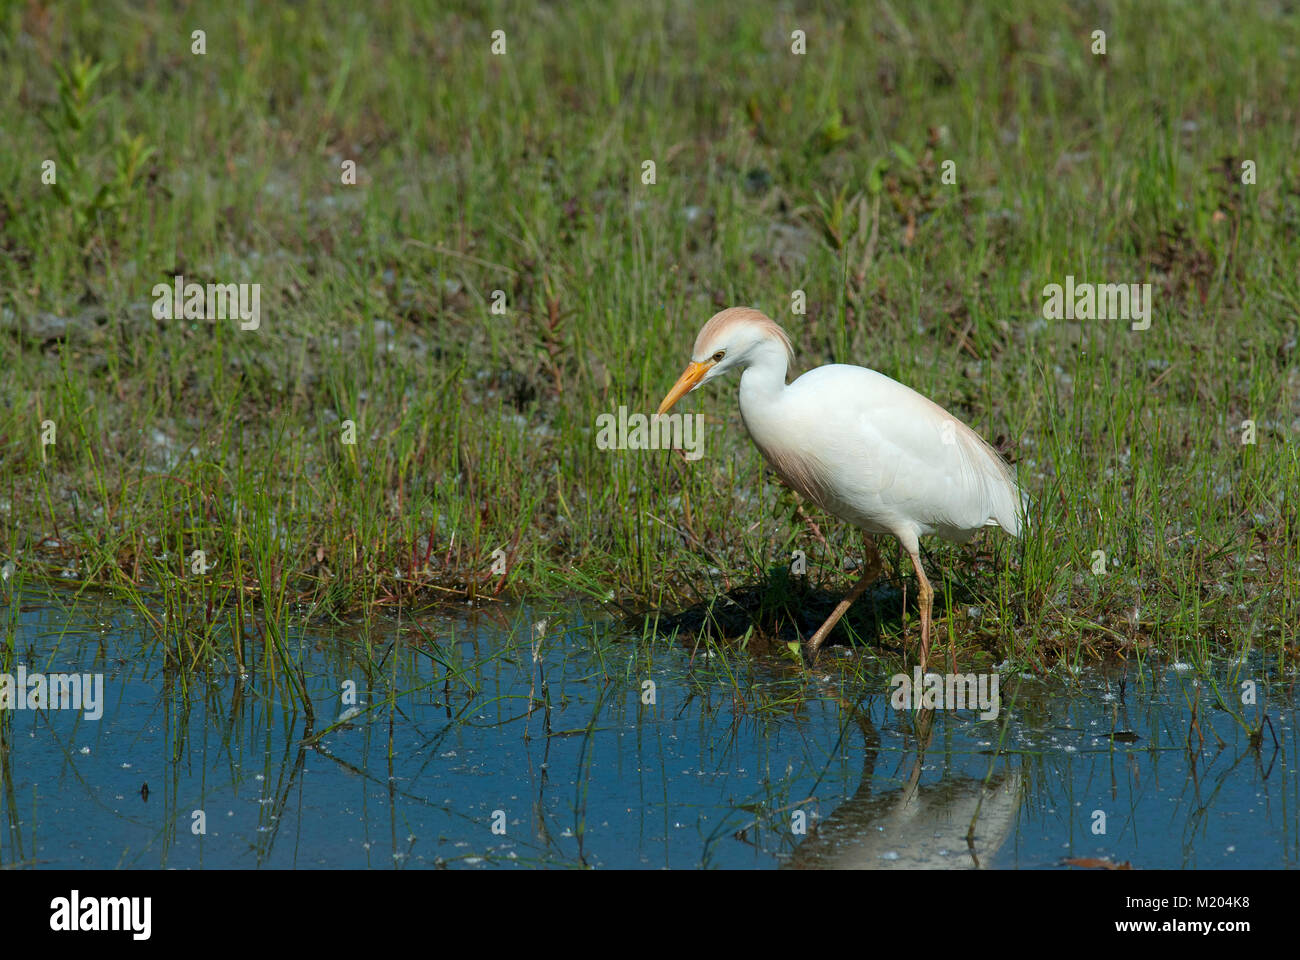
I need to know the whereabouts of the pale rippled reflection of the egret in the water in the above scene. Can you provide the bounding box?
[788,712,1023,870]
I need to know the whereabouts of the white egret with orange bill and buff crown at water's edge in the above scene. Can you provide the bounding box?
[658,307,1027,667]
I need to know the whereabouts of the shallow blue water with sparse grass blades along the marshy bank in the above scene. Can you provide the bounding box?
[0,597,1300,869]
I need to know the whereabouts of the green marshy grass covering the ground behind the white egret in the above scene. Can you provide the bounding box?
[0,3,1300,663]
